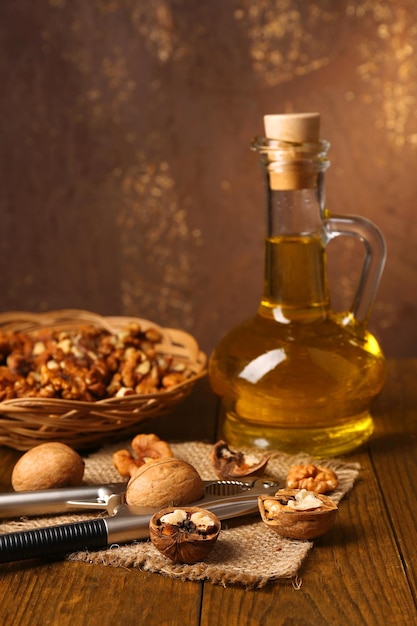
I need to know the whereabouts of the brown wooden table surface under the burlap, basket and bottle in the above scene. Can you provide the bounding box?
[0,359,417,626]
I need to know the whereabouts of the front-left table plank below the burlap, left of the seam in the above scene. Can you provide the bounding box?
[0,562,202,626]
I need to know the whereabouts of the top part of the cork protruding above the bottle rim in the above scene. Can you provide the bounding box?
[264,113,320,143]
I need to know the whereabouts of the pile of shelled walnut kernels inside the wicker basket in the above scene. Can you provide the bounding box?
[0,324,190,402]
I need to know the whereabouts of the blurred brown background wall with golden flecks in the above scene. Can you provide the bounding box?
[0,0,417,356]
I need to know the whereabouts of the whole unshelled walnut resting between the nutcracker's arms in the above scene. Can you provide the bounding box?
[126,457,204,508]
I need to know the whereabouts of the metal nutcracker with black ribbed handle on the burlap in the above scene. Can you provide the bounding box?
[0,479,280,563]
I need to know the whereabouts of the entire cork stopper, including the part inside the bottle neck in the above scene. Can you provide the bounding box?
[264,113,320,190]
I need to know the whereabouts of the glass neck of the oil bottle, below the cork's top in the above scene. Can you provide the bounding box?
[252,140,330,324]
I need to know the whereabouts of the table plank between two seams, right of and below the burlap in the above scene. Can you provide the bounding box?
[201,451,417,626]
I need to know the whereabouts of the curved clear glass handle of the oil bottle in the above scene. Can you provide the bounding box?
[324,215,386,324]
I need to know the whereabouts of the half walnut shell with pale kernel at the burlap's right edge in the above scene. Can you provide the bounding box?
[258,489,338,539]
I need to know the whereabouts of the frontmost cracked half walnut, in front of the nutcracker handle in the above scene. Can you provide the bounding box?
[149,507,221,564]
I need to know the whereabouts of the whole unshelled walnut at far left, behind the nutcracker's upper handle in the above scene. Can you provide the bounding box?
[11,442,84,491]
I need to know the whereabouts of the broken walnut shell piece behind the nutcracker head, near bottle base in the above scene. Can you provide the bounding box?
[211,441,269,480]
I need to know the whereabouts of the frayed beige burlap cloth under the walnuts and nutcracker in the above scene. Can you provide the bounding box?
[0,442,359,588]
